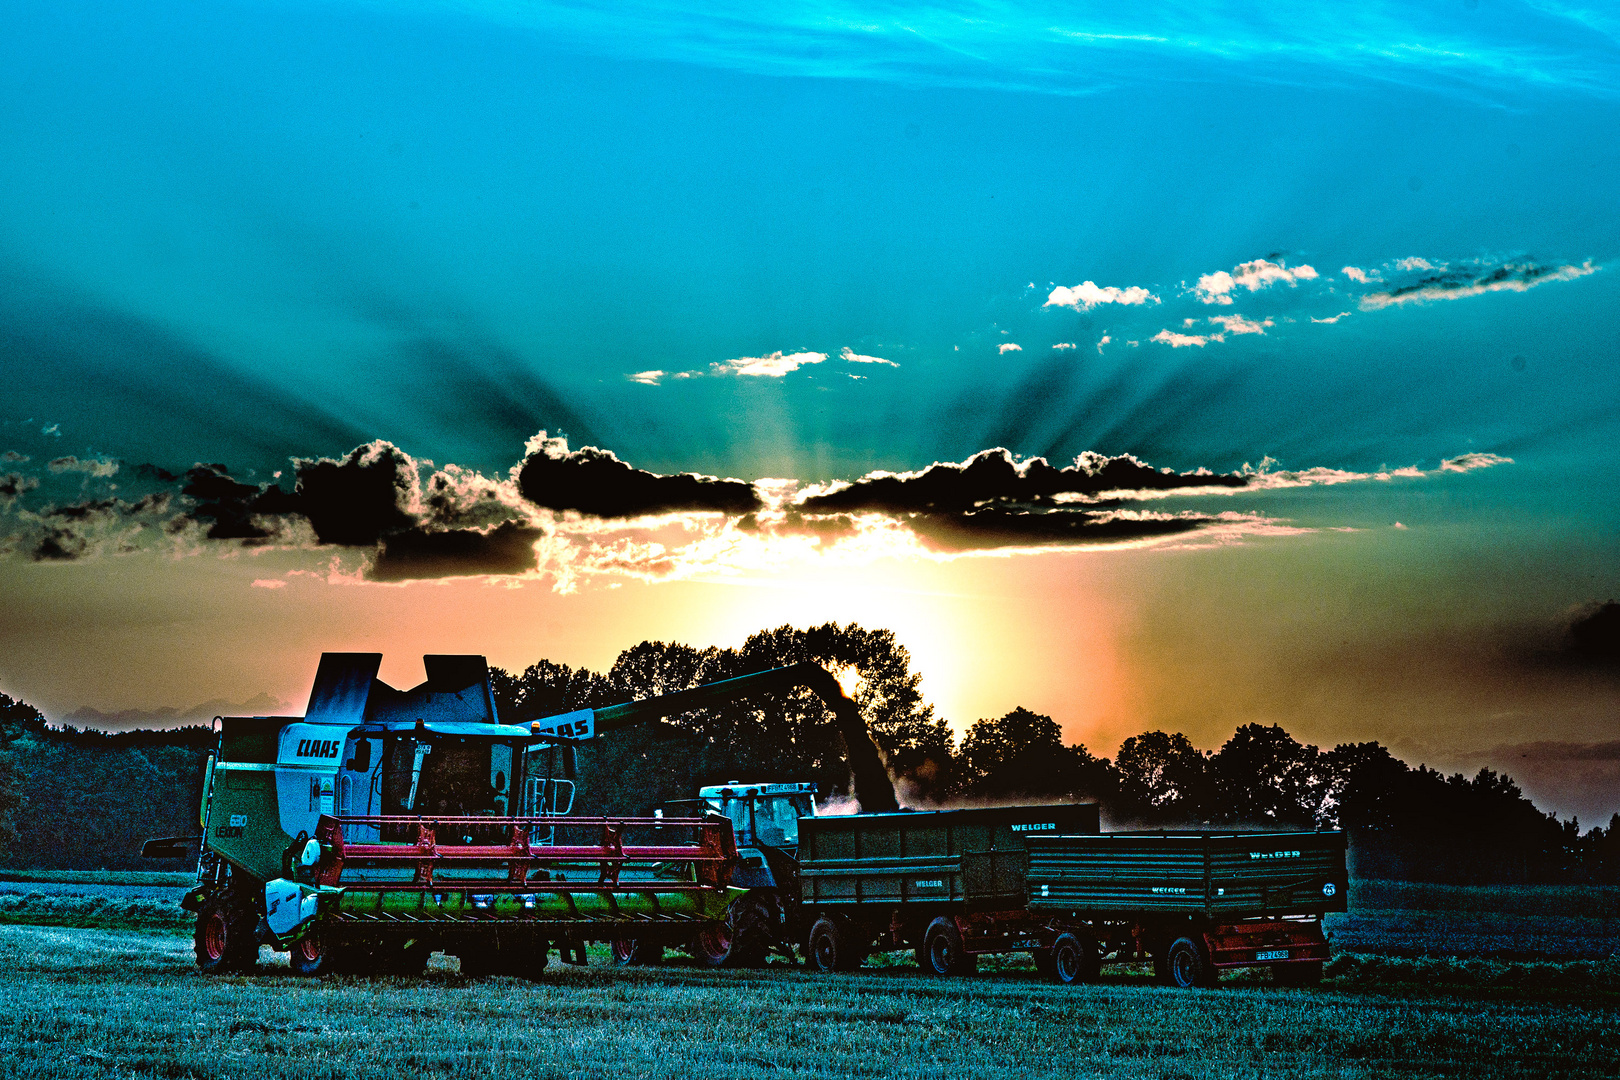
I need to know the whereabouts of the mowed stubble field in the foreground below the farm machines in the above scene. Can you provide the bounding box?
[0,926,1620,1080]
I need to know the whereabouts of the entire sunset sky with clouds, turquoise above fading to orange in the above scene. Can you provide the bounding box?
[0,0,1620,824]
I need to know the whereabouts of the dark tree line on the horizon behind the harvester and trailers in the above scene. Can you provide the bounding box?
[0,623,1620,882]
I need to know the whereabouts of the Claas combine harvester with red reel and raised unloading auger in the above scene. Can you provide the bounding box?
[147,653,896,975]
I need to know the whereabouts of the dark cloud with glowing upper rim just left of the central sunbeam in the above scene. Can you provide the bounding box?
[517,432,763,518]
